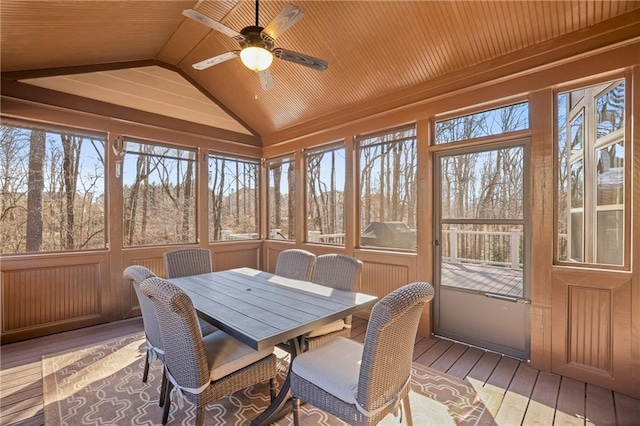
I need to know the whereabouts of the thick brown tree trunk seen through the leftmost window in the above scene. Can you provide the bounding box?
[26,130,46,252]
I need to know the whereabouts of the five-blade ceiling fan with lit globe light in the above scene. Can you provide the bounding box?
[182,0,329,90]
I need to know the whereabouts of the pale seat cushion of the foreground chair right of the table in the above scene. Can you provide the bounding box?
[291,337,363,404]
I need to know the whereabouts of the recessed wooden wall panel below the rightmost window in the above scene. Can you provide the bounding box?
[552,267,640,397]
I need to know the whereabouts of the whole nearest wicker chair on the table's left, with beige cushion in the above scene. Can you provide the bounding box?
[140,277,277,426]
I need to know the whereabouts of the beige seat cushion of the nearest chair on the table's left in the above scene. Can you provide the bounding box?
[203,330,273,381]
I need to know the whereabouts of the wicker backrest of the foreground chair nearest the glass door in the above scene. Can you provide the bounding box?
[356,282,434,411]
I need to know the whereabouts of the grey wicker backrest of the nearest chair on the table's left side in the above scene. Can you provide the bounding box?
[140,277,209,389]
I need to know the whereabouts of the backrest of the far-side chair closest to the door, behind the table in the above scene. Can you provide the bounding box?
[311,254,363,291]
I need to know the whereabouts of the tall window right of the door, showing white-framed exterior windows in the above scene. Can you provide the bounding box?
[557,80,628,265]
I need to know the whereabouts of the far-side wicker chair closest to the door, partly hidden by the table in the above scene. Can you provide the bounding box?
[303,254,363,350]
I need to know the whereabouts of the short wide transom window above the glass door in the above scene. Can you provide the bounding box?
[435,102,529,145]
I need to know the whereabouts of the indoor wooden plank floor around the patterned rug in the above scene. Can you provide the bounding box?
[0,318,640,426]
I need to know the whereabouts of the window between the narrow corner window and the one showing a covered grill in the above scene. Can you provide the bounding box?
[304,143,345,245]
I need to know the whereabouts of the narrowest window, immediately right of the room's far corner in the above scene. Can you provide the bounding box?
[267,156,296,240]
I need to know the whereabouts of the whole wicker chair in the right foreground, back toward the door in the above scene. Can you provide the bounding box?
[290,282,434,426]
